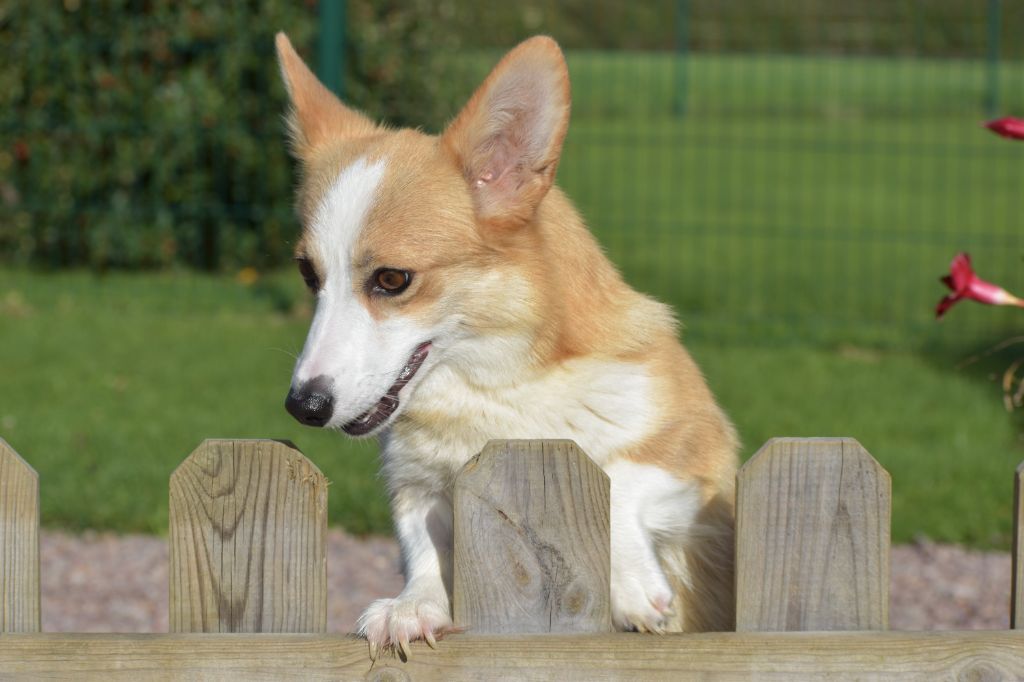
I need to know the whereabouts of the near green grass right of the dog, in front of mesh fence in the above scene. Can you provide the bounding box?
[689,343,1024,549]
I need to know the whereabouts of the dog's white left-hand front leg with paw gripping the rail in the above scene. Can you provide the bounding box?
[357,487,454,657]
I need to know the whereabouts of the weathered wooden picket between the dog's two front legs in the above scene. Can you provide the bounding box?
[453,440,611,634]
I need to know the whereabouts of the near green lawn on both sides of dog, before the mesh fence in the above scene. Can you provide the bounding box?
[0,270,1022,547]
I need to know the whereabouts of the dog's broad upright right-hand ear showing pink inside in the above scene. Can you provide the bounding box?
[441,36,569,226]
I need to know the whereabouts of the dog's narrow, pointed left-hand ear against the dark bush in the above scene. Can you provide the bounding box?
[274,33,377,160]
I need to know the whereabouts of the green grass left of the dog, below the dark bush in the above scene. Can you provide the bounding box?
[0,272,389,532]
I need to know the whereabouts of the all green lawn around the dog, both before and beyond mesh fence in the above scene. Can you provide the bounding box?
[6,52,1024,547]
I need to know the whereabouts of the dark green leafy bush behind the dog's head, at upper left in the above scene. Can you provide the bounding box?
[0,0,464,269]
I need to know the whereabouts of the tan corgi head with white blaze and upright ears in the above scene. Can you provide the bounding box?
[276,34,569,435]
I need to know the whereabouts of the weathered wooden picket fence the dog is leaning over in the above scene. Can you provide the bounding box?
[0,438,1024,681]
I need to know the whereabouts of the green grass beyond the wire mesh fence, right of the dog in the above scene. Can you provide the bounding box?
[559,53,1024,348]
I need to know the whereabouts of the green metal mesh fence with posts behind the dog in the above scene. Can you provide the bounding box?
[0,0,1024,346]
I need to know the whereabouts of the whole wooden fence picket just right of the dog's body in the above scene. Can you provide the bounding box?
[736,438,891,632]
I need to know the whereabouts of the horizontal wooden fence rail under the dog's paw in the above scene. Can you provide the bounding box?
[0,630,1024,682]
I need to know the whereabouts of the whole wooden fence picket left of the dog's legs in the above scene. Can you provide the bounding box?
[169,440,328,633]
